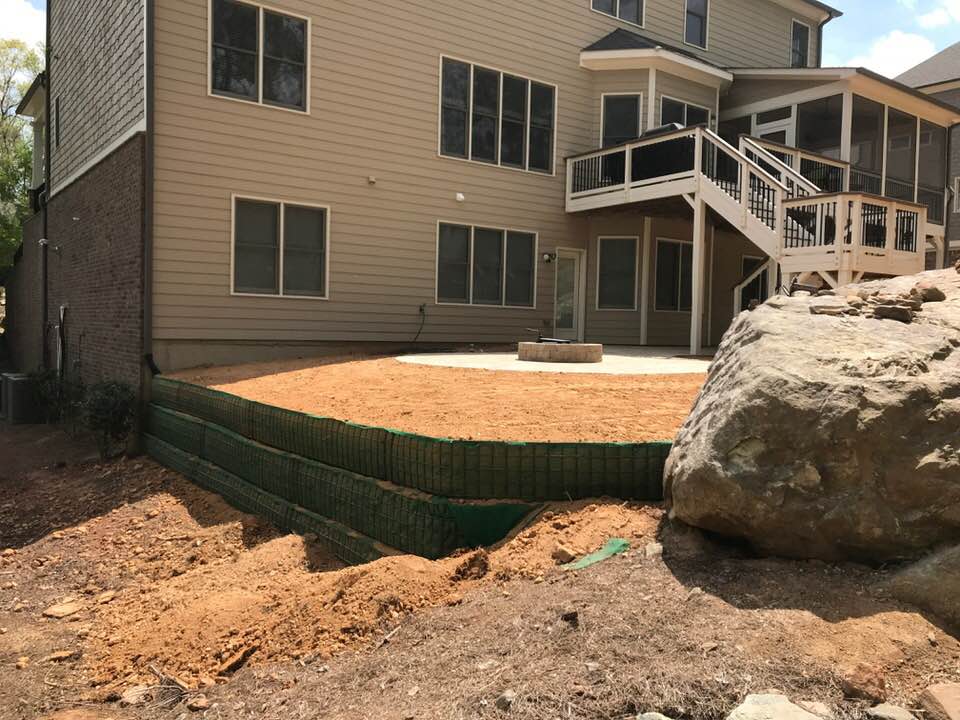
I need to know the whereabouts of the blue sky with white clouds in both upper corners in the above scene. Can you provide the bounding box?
[0,0,960,77]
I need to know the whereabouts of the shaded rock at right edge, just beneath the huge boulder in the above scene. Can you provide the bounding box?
[884,545,960,628]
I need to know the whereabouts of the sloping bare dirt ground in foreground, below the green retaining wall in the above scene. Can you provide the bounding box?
[0,425,960,720]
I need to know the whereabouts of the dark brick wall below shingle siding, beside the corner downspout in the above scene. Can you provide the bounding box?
[48,134,144,388]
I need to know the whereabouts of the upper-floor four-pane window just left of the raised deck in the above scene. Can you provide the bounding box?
[440,58,556,174]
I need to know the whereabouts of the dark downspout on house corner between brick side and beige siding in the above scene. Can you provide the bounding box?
[143,0,160,380]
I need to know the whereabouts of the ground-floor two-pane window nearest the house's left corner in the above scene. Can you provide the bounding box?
[233,198,330,299]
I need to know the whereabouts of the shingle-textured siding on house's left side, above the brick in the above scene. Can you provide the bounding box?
[50,0,145,192]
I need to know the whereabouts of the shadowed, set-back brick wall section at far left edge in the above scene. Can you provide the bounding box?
[4,213,43,372]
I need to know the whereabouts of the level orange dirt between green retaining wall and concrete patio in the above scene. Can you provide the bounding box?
[172,358,705,442]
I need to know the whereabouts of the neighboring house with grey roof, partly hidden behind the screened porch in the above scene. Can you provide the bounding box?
[897,42,960,264]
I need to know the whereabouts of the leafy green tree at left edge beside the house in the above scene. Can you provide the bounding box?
[0,40,43,268]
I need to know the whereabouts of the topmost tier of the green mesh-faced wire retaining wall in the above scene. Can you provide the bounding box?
[153,378,671,502]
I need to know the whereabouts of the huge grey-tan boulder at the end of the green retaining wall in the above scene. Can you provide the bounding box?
[665,270,960,563]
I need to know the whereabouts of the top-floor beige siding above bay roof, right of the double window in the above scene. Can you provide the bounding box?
[625,0,817,67]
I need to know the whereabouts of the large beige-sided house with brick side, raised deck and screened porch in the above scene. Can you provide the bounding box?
[10,0,960,388]
